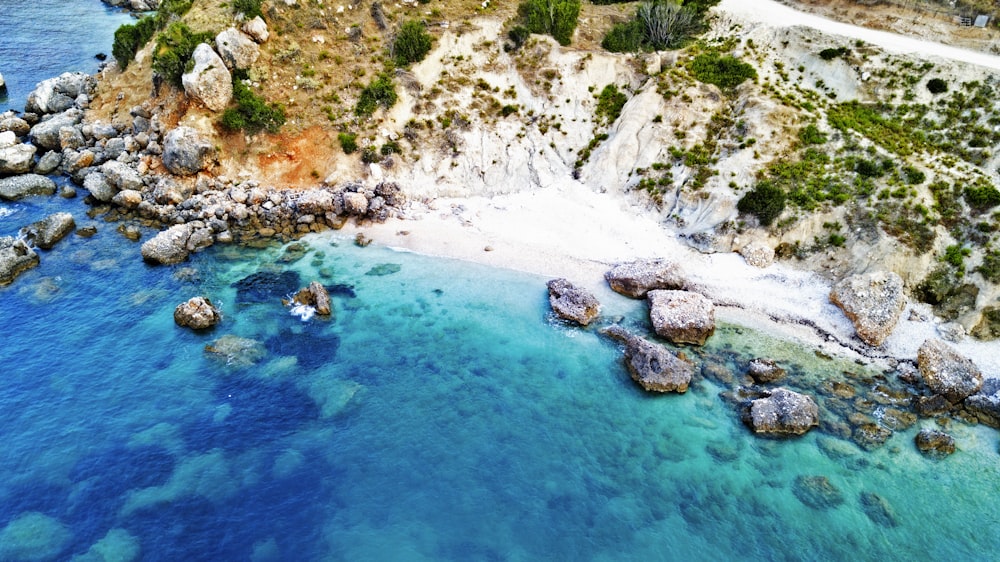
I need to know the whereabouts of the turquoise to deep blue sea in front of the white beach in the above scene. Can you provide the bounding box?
[0,5,1000,561]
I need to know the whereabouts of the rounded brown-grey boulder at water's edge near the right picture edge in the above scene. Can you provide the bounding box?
[917,338,983,404]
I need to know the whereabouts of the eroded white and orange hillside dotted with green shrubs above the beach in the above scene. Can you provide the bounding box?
[78,2,1000,329]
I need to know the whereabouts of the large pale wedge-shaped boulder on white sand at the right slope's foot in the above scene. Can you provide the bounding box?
[830,271,906,346]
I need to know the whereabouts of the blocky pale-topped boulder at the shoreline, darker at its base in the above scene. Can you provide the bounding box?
[646,290,715,345]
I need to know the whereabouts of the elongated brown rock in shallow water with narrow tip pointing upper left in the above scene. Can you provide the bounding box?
[605,326,695,392]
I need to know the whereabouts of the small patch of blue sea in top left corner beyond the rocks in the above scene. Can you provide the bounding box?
[0,0,132,113]
